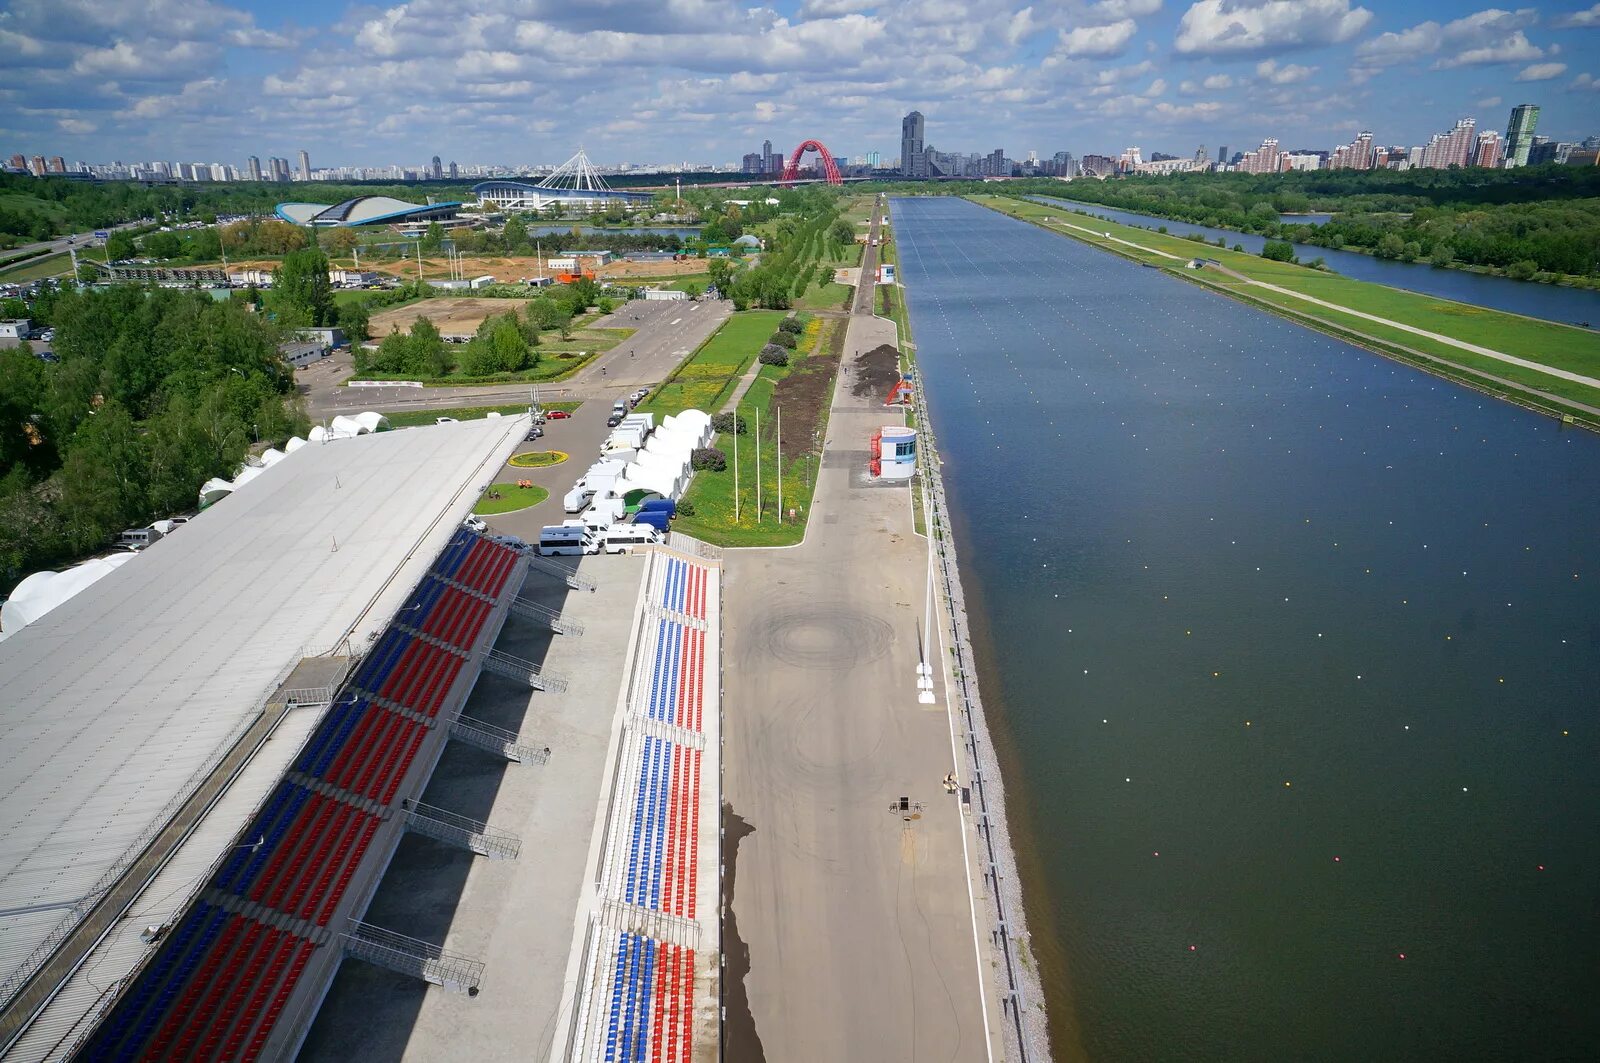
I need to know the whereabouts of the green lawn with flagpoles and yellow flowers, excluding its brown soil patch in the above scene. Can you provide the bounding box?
[674,320,845,546]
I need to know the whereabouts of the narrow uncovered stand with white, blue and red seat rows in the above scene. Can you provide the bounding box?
[552,549,722,1063]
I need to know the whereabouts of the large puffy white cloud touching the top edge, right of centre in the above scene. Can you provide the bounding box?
[1174,0,1373,56]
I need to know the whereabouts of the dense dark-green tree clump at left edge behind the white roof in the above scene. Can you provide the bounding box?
[0,285,309,591]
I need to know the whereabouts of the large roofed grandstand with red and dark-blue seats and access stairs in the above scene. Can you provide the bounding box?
[0,418,538,1060]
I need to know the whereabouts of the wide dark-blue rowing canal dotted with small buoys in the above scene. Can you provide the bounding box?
[893,199,1600,1061]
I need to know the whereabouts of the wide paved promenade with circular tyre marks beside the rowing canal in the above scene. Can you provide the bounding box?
[723,201,998,1063]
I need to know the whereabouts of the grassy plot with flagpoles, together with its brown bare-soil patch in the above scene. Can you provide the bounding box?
[674,319,846,546]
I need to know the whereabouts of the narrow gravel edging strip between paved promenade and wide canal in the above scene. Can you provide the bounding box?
[917,365,1051,1063]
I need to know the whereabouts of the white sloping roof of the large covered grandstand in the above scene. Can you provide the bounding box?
[0,418,526,1030]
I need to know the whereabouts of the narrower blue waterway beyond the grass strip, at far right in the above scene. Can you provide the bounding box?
[1030,195,1600,327]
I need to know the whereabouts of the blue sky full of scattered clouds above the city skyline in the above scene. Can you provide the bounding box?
[0,0,1600,166]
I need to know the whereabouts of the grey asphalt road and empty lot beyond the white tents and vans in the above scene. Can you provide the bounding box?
[294,299,733,419]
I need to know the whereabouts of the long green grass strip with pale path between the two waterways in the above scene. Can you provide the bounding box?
[971,195,1600,407]
